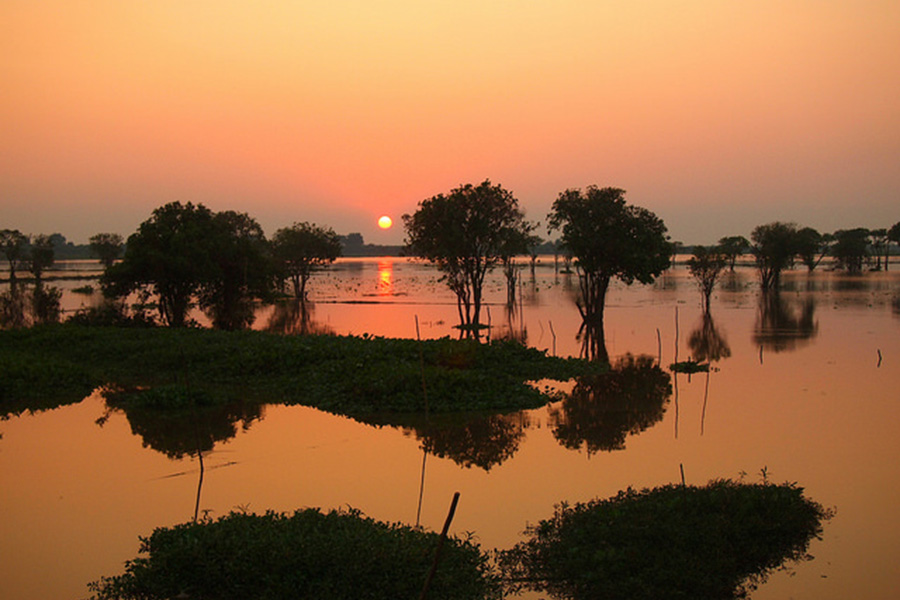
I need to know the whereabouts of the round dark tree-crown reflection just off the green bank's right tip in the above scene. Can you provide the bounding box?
[549,354,672,454]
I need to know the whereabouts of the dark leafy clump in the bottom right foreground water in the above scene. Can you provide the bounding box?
[500,480,832,600]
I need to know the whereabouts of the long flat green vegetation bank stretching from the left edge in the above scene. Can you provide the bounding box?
[0,324,598,416]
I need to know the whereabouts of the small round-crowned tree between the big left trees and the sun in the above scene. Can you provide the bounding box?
[272,223,342,301]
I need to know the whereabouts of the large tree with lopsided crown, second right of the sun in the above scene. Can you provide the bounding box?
[548,186,673,352]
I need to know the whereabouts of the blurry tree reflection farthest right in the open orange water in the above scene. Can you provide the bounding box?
[753,290,819,354]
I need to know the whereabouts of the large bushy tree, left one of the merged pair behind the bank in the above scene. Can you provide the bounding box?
[103,202,214,327]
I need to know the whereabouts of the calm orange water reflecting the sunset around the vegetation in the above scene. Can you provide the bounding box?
[0,258,900,600]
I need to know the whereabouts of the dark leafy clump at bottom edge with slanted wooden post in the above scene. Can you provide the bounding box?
[89,509,500,600]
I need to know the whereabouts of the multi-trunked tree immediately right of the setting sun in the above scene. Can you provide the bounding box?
[403,180,525,334]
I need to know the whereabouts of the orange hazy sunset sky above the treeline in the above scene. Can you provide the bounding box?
[0,0,900,244]
